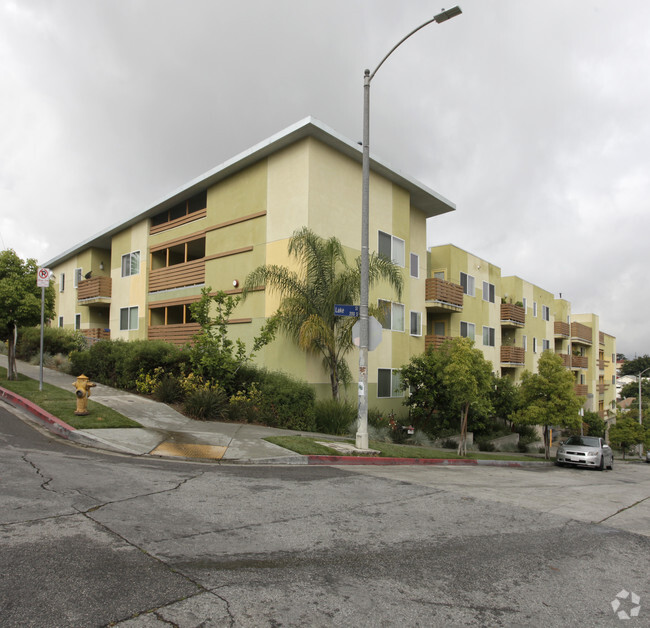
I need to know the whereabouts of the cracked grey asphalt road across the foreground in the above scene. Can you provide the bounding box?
[0,405,650,628]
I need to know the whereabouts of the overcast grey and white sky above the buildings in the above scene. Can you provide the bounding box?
[0,0,650,357]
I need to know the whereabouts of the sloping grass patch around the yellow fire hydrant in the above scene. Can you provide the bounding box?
[0,367,142,430]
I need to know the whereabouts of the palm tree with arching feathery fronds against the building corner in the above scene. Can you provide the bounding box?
[243,227,403,399]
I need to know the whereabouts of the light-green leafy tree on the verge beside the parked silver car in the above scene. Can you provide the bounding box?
[511,351,584,460]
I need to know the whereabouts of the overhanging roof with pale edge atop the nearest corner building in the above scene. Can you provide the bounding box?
[43,117,456,267]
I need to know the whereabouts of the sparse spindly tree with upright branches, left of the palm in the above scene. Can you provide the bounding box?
[189,287,277,393]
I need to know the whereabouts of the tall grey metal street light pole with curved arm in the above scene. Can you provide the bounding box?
[356,6,462,449]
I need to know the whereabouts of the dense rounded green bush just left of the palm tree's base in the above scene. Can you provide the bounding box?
[253,370,316,432]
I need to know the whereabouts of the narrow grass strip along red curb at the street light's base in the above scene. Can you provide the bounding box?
[265,436,542,462]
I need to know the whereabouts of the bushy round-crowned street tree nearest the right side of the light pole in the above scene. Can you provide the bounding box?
[401,338,494,454]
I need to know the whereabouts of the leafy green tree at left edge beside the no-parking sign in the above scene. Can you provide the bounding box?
[0,249,54,380]
